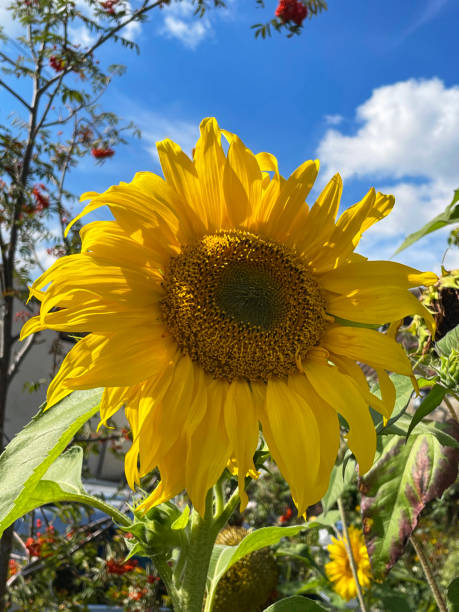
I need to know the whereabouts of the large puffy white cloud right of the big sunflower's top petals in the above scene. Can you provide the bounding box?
[318,78,459,268]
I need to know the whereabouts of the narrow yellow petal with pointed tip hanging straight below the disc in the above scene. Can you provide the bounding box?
[224,380,258,512]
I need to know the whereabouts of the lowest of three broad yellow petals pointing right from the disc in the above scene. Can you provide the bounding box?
[320,326,413,376]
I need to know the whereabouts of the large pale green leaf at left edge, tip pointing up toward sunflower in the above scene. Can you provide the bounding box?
[0,389,102,535]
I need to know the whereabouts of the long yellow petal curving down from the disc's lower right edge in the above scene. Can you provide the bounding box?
[304,361,376,474]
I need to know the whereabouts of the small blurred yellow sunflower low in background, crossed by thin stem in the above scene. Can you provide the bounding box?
[325,525,371,601]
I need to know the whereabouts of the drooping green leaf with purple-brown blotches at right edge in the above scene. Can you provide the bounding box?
[359,420,459,580]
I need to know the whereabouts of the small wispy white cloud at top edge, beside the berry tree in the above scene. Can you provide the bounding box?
[160,0,212,49]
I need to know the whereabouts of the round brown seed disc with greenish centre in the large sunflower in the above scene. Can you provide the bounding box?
[161,230,326,381]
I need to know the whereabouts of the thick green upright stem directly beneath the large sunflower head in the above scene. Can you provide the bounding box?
[176,489,218,612]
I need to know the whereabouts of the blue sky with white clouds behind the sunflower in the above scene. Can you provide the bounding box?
[0,0,459,271]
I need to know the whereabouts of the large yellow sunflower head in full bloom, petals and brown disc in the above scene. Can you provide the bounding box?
[22,118,436,514]
